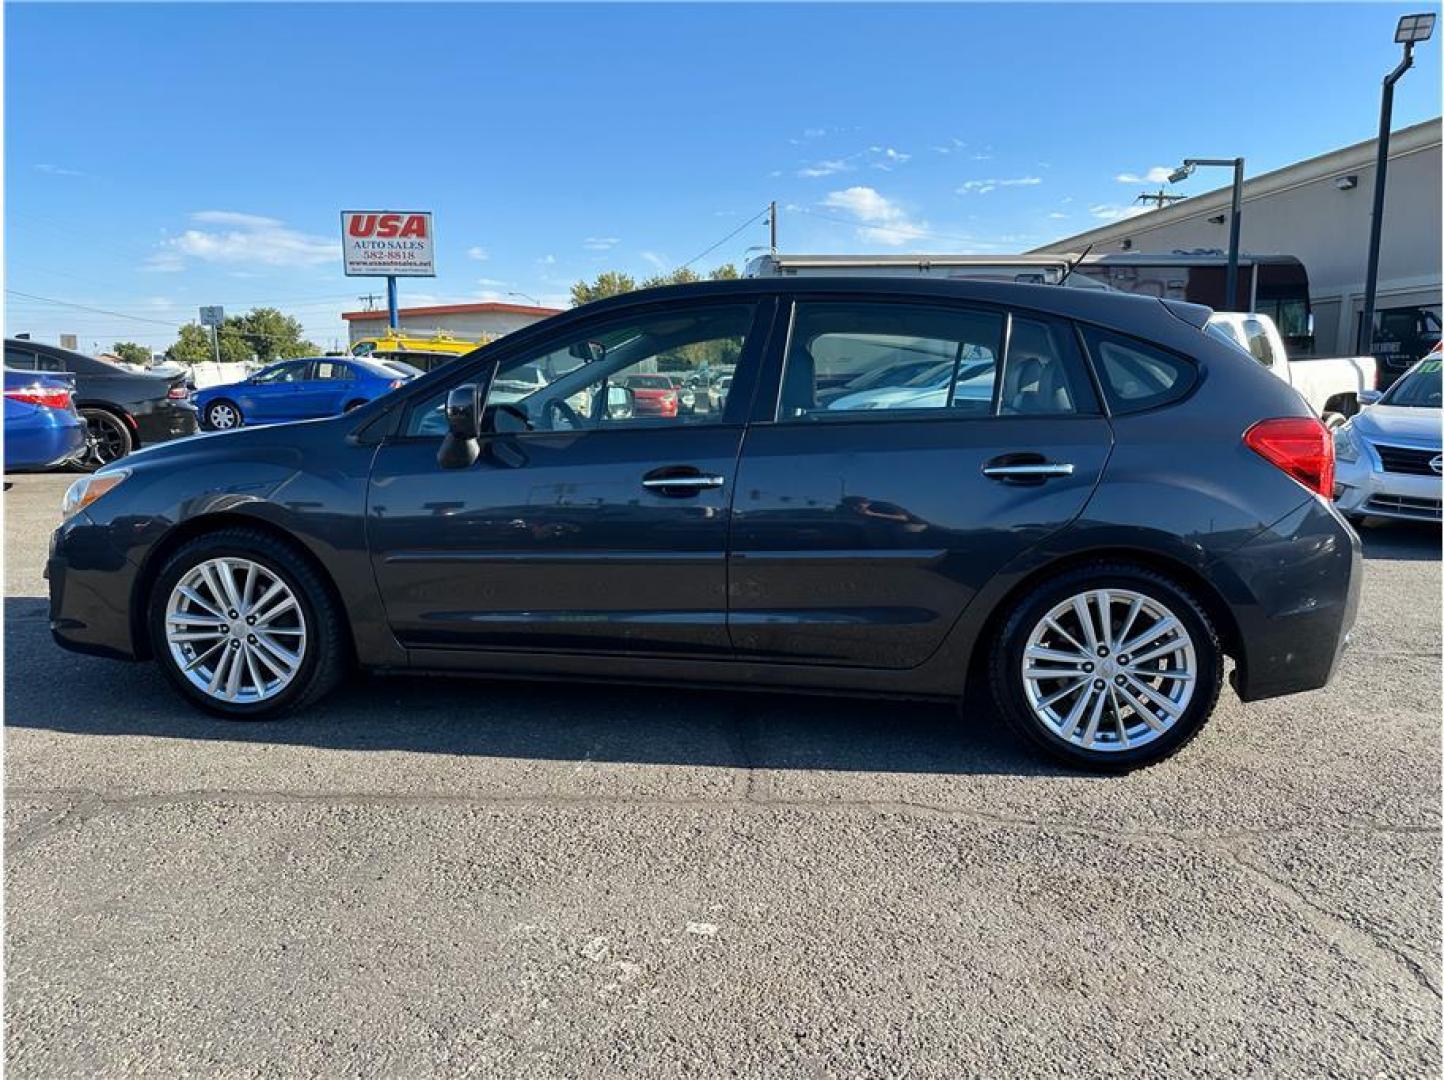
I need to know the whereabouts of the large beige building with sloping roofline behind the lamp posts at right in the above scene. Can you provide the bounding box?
[1035,118,1441,357]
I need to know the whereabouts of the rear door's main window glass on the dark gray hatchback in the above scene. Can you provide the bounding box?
[778,303,1004,420]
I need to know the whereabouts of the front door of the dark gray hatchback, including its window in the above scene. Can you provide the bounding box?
[368,300,771,663]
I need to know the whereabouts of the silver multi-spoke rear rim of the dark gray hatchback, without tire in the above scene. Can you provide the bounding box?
[1021,589,1197,752]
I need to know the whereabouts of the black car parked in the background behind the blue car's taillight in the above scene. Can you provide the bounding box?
[4,338,196,469]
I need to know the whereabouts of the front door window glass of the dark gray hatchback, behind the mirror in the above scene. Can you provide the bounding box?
[406,303,754,436]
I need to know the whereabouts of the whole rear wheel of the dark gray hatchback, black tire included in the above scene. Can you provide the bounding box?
[988,563,1223,772]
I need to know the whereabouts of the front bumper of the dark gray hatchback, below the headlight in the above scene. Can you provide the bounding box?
[45,513,137,660]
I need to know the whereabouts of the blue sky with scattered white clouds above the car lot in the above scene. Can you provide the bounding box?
[4,3,1441,348]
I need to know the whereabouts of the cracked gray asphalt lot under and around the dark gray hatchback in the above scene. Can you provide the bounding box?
[4,476,1441,1077]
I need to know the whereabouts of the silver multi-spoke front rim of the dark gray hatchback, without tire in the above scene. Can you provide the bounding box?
[165,557,306,703]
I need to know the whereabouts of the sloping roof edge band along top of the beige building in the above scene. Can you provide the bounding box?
[1028,117,1441,256]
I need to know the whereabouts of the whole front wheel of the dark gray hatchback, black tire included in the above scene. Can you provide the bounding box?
[149,528,345,719]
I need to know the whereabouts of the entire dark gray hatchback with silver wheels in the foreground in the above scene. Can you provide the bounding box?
[49,279,1360,768]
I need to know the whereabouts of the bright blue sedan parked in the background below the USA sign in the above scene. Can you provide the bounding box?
[192,357,407,432]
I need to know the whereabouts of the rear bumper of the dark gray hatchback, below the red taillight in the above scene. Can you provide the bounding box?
[1212,498,1363,702]
